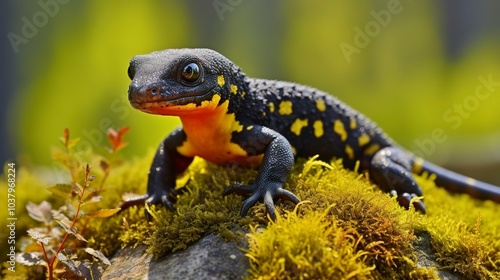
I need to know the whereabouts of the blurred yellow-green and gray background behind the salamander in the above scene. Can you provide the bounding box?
[1,0,500,184]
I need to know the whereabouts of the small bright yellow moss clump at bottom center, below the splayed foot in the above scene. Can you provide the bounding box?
[247,205,375,279]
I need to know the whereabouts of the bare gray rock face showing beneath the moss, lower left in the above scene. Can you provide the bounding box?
[102,234,249,280]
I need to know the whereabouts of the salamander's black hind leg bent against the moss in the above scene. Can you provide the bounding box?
[369,147,426,214]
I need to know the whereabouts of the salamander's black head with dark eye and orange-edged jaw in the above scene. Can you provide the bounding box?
[128,49,243,116]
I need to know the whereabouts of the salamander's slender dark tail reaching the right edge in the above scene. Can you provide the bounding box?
[413,158,500,203]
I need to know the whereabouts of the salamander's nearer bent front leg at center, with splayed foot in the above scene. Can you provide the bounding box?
[224,126,300,220]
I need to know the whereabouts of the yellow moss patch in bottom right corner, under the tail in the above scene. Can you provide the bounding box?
[410,176,500,279]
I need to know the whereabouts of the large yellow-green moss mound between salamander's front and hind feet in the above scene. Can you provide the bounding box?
[248,160,437,279]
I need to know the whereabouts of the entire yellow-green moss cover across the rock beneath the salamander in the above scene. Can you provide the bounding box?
[3,152,500,279]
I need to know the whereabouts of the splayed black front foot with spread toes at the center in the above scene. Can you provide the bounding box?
[222,182,300,221]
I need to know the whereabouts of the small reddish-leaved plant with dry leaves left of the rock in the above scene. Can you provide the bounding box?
[17,128,129,279]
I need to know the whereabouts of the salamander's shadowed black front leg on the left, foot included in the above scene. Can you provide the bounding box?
[121,127,193,219]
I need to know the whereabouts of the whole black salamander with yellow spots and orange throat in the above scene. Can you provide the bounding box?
[122,49,500,219]
